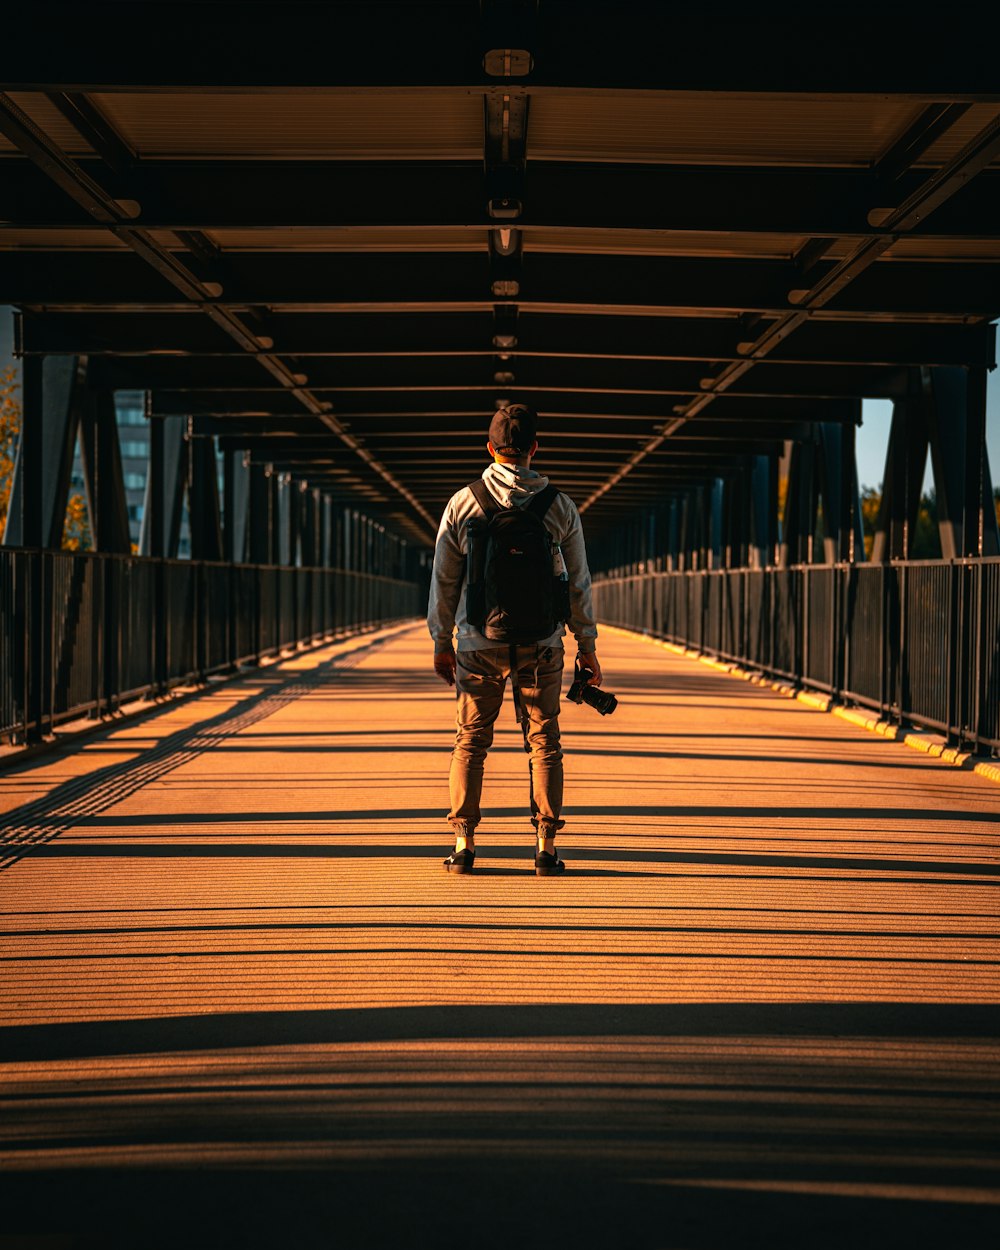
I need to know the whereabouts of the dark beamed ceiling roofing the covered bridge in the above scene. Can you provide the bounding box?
[0,0,1000,541]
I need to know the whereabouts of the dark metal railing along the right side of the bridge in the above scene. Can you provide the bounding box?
[594,558,1000,751]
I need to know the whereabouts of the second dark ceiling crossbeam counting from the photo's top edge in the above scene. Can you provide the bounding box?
[0,158,1000,236]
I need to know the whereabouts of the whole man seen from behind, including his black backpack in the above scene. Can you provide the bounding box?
[428,404,603,876]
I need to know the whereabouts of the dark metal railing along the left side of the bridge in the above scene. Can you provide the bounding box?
[0,548,424,741]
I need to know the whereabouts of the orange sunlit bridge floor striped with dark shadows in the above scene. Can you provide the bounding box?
[0,628,1000,1248]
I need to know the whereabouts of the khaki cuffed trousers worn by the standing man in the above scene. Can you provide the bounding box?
[449,643,564,833]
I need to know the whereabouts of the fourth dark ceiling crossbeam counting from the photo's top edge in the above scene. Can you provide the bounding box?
[19,309,996,369]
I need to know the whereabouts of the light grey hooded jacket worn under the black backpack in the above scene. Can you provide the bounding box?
[428,461,598,653]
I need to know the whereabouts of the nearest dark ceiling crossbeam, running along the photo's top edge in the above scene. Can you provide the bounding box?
[4,0,998,93]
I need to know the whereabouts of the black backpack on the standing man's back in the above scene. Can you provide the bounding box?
[465,479,570,644]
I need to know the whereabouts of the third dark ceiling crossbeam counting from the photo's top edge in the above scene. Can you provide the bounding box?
[7,250,1000,320]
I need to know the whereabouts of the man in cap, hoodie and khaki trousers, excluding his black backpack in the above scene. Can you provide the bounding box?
[428,404,603,876]
